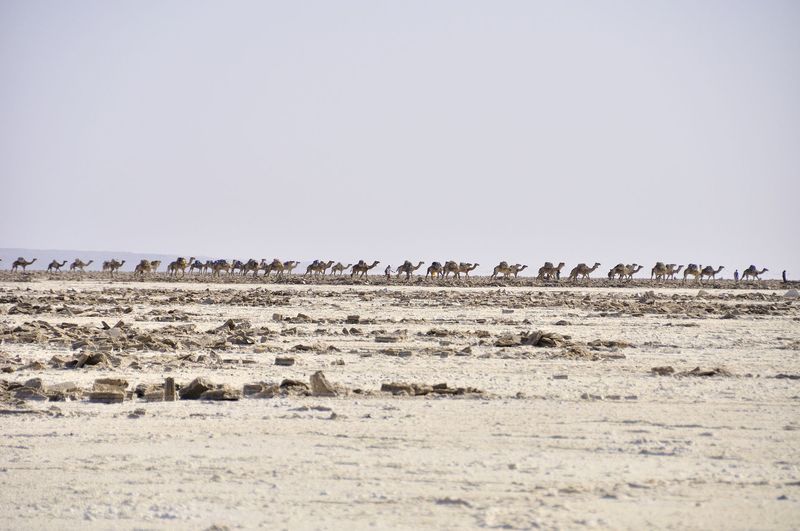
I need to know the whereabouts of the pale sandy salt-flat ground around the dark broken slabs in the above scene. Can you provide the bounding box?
[0,277,800,529]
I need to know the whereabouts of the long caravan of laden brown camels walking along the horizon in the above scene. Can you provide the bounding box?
[3,257,769,282]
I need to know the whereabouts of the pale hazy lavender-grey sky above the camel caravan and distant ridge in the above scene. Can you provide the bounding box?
[0,0,800,276]
